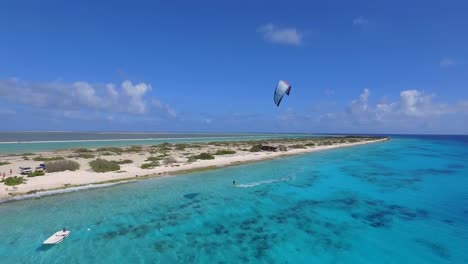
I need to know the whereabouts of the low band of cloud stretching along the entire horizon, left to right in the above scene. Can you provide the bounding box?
[0,78,468,133]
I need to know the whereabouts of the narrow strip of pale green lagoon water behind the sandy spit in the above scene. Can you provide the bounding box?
[0,132,313,154]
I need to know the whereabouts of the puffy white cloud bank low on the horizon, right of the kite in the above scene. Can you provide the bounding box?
[310,89,468,134]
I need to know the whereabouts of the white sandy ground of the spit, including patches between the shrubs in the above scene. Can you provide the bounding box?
[0,138,387,200]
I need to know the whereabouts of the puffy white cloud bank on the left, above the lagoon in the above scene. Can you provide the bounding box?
[0,78,176,118]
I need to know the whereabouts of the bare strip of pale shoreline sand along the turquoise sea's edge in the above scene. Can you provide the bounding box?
[0,138,389,204]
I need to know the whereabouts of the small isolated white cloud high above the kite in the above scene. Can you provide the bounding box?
[257,23,303,46]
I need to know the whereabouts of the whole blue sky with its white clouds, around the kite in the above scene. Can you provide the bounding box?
[0,1,468,134]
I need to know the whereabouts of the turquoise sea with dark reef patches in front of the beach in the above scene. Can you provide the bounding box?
[0,137,468,263]
